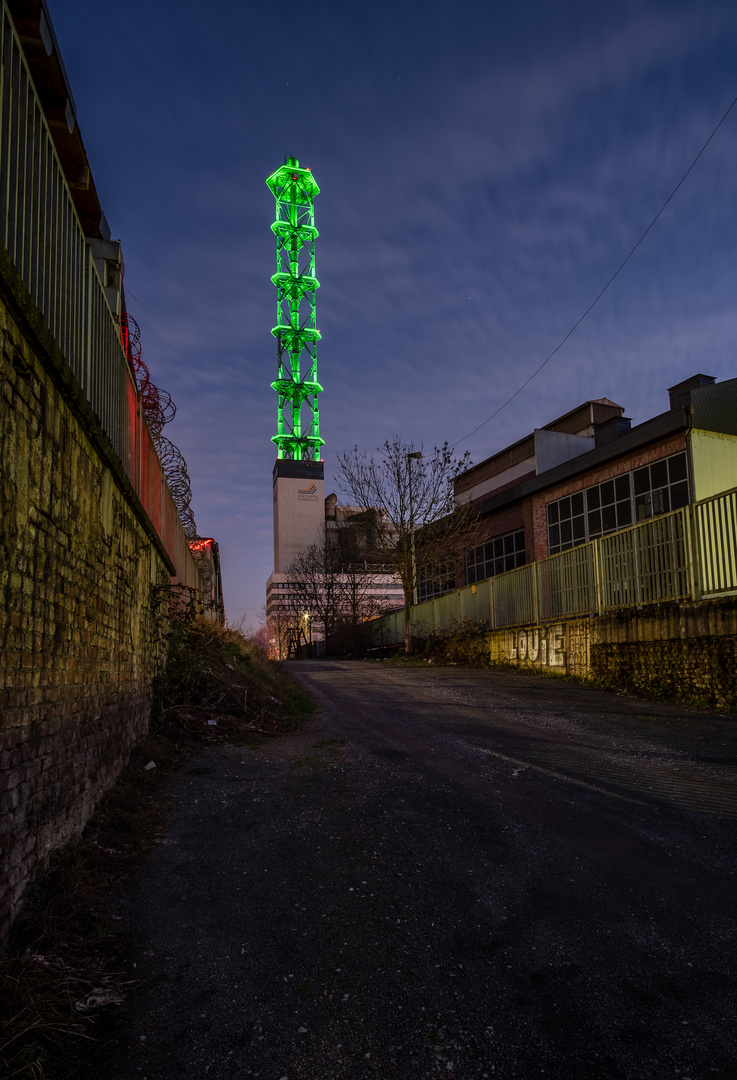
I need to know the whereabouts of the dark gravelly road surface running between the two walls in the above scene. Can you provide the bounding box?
[85,661,737,1080]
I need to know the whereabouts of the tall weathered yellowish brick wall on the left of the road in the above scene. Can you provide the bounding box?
[0,270,175,940]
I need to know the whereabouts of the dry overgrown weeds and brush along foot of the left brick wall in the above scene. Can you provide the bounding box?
[0,613,312,1080]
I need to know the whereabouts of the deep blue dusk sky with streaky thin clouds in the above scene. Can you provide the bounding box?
[49,0,737,627]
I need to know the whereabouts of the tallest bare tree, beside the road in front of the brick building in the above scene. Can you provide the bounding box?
[337,435,472,652]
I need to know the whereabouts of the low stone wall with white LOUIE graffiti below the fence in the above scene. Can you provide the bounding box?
[488,596,737,708]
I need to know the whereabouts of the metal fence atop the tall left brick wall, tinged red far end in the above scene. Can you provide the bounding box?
[0,0,199,586]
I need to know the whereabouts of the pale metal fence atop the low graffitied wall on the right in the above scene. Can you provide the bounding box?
[369,488,737,645]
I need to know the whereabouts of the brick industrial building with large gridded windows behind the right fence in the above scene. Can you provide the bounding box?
[430,374,737,599]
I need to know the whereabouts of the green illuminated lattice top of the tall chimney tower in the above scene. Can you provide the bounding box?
[266,158,324,461]
